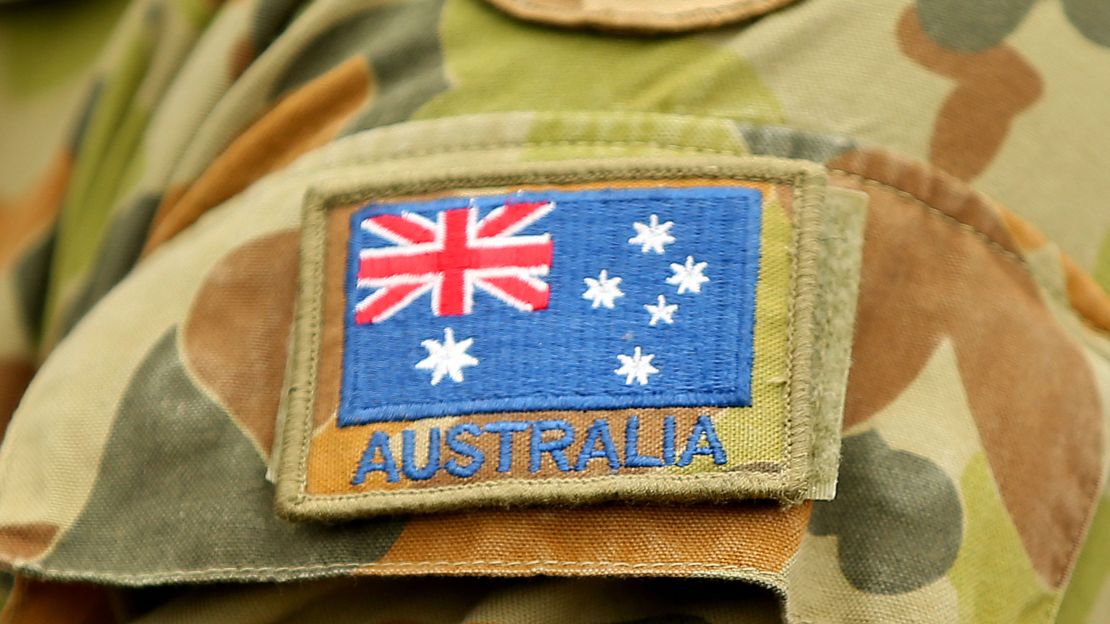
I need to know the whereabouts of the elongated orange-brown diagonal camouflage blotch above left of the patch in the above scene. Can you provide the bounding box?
[143,57,372,255]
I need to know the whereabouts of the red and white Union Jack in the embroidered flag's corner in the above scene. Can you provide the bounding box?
[354,202,555,324]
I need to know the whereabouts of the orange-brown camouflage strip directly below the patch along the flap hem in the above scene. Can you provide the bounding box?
[361,503,811,575]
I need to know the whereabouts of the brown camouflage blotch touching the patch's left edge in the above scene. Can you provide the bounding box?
[182,230,300,454]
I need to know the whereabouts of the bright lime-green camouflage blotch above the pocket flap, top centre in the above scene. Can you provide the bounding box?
[416,0,784,123]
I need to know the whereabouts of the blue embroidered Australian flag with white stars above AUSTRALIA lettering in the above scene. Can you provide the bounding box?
[339,187,760,426]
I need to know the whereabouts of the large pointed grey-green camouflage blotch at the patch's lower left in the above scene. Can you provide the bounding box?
[43,329,404,578]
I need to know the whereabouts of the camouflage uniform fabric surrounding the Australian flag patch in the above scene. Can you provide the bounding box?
[0,0,1110,624]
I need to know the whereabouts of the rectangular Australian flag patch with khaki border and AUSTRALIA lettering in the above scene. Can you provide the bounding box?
[278,160,851,519]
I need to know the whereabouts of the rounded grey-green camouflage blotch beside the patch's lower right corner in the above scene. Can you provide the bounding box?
[809,431,963,594]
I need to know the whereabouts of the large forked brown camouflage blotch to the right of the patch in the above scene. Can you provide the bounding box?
[833,153,1102,586]
